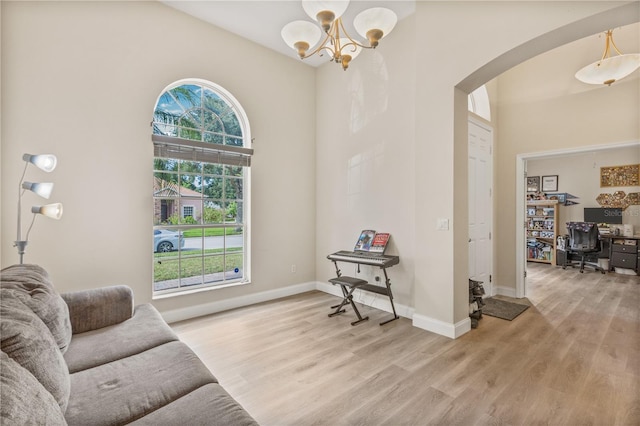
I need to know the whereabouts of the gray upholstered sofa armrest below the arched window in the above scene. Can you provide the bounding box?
[61,285,133,334]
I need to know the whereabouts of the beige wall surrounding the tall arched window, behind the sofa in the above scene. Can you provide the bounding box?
[1,1,315,312]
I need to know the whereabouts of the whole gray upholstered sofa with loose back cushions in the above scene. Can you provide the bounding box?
[0,265,257,426]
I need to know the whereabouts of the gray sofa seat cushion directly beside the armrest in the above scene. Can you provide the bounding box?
[64,304,178,373]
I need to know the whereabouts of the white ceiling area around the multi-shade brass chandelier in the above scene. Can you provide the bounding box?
[161,0,415,66]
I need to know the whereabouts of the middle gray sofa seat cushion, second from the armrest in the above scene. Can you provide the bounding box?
[65,341,216,426]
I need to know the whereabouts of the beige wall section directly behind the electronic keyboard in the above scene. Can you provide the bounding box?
[316,12,416,306]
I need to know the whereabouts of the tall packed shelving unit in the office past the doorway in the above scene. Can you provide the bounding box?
[526,200,558,265]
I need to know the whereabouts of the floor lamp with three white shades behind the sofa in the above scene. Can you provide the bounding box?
[13,154,62,264]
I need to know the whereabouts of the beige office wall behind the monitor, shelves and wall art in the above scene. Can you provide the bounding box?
[527,145,640,234]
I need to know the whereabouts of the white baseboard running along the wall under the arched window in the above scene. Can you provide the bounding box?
[161,282,316,324]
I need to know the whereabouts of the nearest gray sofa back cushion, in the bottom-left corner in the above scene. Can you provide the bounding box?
[0,352,67,426]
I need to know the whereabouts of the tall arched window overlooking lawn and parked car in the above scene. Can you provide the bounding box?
[152,79,253,296]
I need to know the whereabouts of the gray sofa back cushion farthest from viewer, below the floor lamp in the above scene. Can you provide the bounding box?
[0,265,71,353]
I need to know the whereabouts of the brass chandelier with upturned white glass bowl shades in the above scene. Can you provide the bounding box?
[281,0,398,70]
